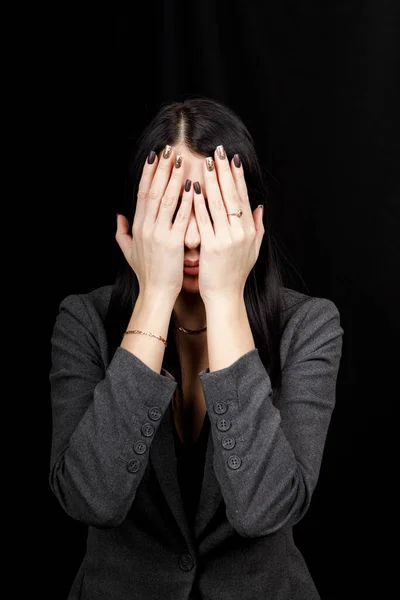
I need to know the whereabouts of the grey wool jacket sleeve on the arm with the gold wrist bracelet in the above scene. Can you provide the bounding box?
[49,295,177,528]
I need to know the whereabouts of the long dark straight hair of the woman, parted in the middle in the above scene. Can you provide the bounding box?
[106,96,284,389]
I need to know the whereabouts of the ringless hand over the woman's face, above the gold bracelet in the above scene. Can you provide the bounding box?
[115,146,193,301]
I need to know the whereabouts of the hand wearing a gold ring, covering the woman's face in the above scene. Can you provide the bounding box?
[194,146,264,303]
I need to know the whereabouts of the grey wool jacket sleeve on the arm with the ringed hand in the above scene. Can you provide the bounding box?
[200,298,343,537]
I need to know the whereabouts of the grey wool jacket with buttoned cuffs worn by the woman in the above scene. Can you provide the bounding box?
[49,286,343,600]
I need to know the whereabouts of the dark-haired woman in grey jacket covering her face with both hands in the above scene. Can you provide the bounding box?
[50,98,343,600]
